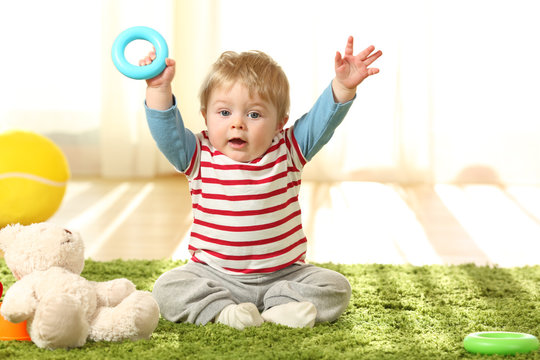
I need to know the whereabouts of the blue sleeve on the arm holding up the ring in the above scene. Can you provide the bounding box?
[144,99,197,172]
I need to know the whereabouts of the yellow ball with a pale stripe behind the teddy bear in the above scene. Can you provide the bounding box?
[0,131,69,228]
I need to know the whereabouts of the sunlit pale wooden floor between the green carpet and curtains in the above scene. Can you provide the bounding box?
[50,175,540,267]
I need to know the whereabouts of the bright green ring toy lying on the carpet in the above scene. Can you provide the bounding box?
[463,331,540,355]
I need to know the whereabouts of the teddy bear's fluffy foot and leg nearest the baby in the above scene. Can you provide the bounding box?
[90,291,159,341]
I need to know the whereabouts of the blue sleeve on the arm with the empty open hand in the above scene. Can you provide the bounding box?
[293,85,354,161]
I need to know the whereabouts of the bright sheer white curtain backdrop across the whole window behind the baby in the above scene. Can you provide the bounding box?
[0,0,540,184]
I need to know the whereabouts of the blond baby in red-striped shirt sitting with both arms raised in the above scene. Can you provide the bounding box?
[140,37,382,329]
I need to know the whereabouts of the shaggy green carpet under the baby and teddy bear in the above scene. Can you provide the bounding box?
[0,260,540,360]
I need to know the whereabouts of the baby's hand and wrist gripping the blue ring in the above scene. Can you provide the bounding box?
[139,51,176,110]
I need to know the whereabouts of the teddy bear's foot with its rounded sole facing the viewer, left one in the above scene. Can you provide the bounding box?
[30,294,89,349]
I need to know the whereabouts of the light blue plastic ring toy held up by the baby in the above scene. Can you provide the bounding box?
[112,26,169,80]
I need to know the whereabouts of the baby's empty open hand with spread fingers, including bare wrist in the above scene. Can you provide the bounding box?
[332,36,382,103]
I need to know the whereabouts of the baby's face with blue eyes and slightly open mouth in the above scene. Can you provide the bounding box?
[203,81,286,162]
